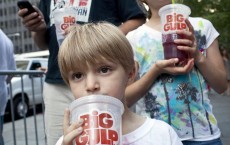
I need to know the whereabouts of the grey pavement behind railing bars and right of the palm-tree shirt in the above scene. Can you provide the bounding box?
[3,91,230,145]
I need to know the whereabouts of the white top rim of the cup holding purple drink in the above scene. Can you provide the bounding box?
[158,4,191,16]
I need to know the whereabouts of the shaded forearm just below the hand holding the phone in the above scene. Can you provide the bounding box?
[32,30,48,50]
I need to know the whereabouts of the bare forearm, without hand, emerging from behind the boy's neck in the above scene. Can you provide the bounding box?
[125,64,160,107]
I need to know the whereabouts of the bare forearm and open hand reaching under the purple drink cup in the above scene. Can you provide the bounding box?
[125,58,194,107]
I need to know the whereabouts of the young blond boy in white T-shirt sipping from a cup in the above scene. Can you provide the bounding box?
[56,22,182,145]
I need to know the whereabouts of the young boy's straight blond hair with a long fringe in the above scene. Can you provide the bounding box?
[58,22,134,85]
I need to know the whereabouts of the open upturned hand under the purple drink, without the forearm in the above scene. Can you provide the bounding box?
[154,58,194,75]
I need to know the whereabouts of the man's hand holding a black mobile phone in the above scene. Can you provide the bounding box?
[18,6,46,32]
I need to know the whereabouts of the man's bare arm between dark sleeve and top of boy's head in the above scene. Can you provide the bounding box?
[119,18,146,35]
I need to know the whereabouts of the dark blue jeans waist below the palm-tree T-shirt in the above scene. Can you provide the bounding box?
[182,138,223,145]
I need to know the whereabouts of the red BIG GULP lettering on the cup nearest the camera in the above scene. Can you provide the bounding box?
[76,110,119,145]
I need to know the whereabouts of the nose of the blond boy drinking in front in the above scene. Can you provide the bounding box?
[86,75,100,93]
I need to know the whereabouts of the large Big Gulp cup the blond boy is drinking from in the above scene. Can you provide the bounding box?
[69,95,124,145]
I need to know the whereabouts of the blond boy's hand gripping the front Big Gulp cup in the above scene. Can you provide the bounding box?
[62,109,83,145]
